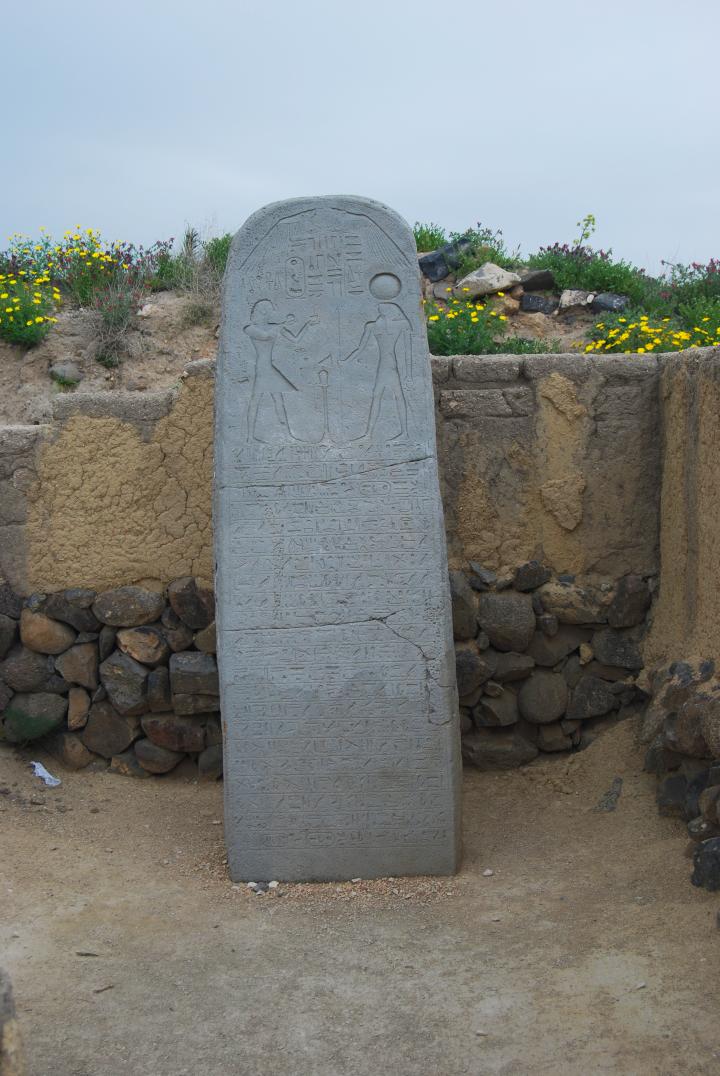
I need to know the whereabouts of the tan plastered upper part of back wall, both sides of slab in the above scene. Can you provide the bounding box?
[0,354,660,594]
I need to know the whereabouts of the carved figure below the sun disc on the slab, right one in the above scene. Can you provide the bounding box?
[344,302,411,441]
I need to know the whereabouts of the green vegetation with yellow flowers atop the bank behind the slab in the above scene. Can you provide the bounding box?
[0,213,720,367]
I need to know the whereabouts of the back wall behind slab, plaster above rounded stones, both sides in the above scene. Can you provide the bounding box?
[0,355,661,777]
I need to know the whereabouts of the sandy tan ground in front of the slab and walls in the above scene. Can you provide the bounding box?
[0,722,720,1076]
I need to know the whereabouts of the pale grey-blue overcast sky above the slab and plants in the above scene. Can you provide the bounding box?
[0,0,720,271]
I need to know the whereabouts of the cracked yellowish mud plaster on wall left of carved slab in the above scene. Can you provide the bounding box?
[21,362,214,592]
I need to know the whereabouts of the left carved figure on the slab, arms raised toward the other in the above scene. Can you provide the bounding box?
[243,299,320,441]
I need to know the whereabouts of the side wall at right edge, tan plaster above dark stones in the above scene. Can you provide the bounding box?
[628,349,720,890]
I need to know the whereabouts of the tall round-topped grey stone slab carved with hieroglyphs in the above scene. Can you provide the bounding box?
[214,197,460,881]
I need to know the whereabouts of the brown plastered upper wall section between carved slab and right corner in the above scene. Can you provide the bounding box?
[435,355,660,579]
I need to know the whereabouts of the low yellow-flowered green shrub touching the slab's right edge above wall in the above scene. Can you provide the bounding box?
[426,299,549,355]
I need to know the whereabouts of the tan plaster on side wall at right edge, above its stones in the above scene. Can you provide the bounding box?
[645,349,720,666]
